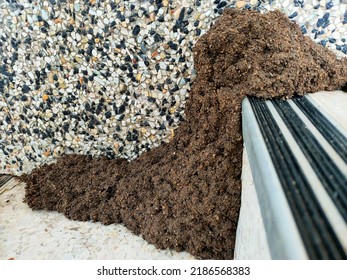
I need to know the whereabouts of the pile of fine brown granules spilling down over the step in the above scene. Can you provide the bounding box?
[22,10,347,259]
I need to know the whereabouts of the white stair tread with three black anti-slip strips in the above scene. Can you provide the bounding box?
[236,91,347,259]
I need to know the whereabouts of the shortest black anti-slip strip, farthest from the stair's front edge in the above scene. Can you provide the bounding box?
[292,96,347,163]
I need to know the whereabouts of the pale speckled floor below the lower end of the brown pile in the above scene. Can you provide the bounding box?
[0,180,193,260]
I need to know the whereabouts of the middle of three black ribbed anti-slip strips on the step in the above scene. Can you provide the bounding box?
[272,100,347,222]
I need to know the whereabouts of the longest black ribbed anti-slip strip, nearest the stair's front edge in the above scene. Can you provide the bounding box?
[249,98,346,259]
